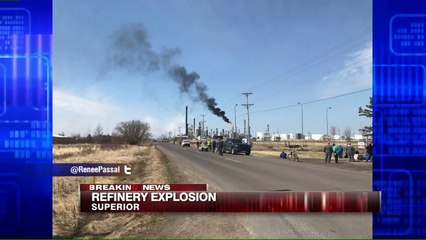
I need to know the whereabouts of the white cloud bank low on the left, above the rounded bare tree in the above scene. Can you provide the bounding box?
[53,88,185,137]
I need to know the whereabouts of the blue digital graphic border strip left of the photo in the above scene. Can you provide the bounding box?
[0,0,53,239]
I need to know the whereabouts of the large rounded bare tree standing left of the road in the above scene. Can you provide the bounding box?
[115,120,151,145]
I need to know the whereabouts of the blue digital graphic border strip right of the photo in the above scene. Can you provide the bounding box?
[373,0,426,239]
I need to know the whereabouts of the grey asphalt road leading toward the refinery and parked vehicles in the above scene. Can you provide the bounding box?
[157,143,372,238]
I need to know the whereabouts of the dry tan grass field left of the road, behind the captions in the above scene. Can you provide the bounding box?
[53,144,171,238]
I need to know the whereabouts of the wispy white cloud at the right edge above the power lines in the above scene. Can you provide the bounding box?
[319,44,372,98]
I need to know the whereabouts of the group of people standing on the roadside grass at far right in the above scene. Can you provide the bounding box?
[324,141,373,163]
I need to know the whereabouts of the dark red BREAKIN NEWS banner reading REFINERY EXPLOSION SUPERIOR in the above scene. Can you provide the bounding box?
[80,184,381,212]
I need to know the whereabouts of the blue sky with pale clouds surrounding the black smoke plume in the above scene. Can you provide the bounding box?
[52,0,372,136]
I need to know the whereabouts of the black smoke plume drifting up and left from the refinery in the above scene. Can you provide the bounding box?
[107,24,230,123]
